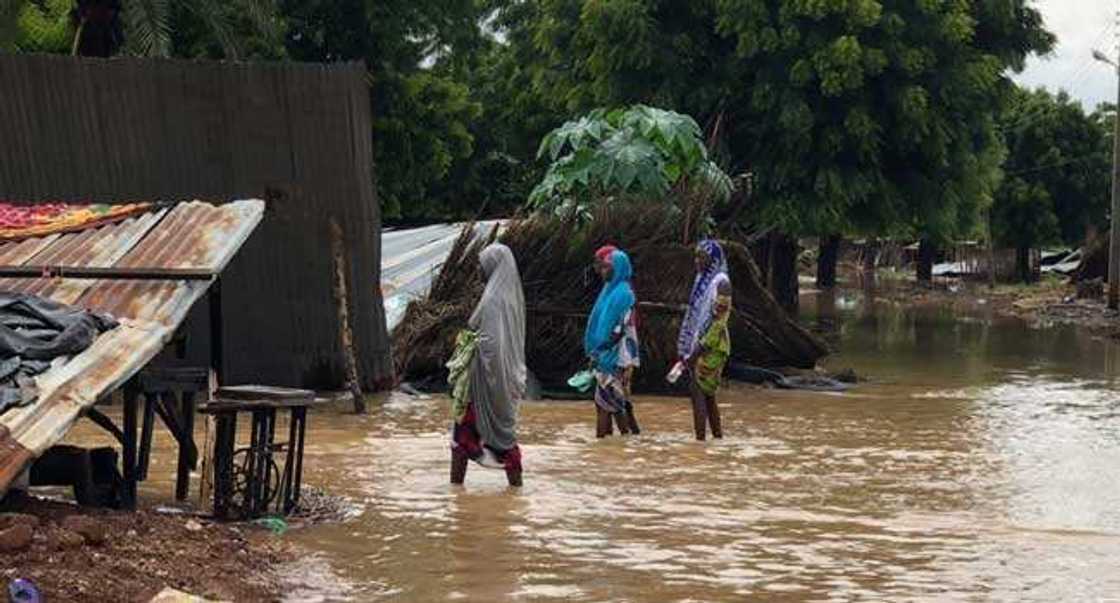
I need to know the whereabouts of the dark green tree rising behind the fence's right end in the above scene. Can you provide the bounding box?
[281,0,486,219]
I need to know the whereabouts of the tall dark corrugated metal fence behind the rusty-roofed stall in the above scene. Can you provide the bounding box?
[0,55,392,389]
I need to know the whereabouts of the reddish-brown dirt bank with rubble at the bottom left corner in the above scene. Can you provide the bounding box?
[0,498,293,603]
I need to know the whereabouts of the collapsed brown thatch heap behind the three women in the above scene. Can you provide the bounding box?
[393,206,827,391]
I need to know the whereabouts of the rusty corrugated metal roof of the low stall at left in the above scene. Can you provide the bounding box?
[0,201,264,494]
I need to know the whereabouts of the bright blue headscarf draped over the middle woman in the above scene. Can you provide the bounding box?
[584,250,635,374]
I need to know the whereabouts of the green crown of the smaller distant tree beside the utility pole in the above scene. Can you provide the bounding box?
[992,90,1112,249]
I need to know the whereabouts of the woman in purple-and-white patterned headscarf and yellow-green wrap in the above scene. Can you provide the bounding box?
[676,239,731,439]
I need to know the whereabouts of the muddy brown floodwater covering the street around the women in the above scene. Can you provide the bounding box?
[71,289,1120,602]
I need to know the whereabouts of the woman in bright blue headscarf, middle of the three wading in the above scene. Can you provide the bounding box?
[584,245,641,437]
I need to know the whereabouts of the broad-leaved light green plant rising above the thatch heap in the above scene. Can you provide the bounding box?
[529,104,731,211]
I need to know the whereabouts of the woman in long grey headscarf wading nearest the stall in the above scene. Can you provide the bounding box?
[448,243,525,486]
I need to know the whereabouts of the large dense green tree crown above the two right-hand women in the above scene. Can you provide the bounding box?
[490,0,1053,295]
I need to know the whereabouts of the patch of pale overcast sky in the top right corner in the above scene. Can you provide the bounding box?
[1015,0,1120,110]
